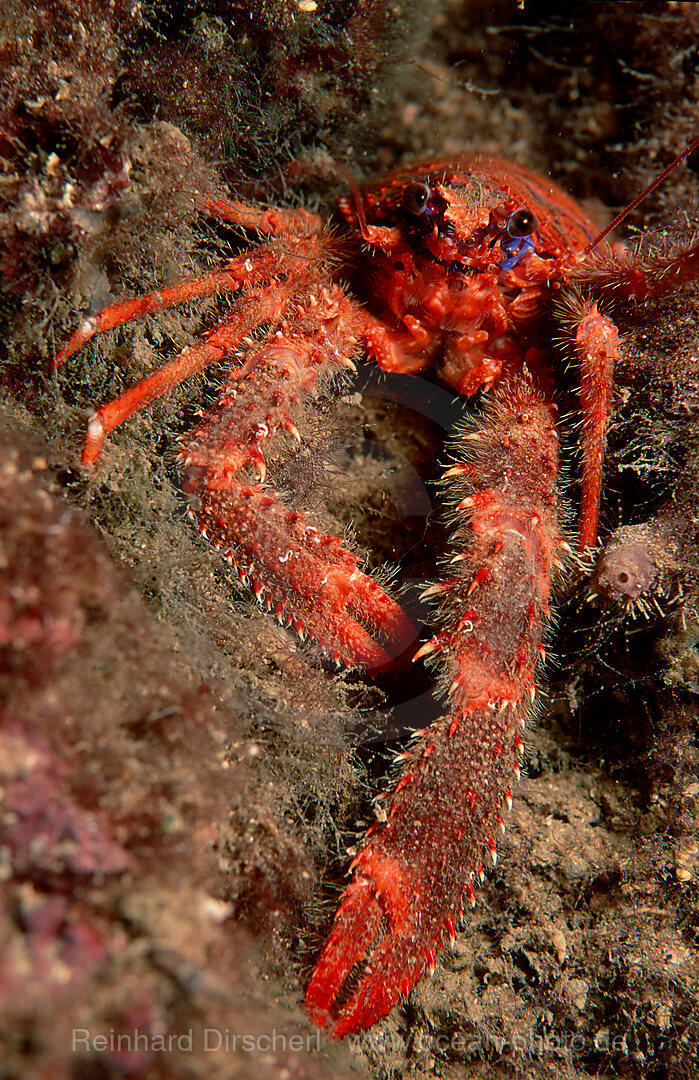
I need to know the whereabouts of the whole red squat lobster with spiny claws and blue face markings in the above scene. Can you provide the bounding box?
[56,139,699,1037]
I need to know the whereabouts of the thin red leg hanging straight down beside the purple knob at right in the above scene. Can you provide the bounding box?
[575,300,619,553]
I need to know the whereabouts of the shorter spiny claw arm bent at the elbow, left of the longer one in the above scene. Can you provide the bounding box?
[180,287,417,670]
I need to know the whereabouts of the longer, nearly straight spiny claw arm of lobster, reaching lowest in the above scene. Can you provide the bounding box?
[306,376,564,1038]
